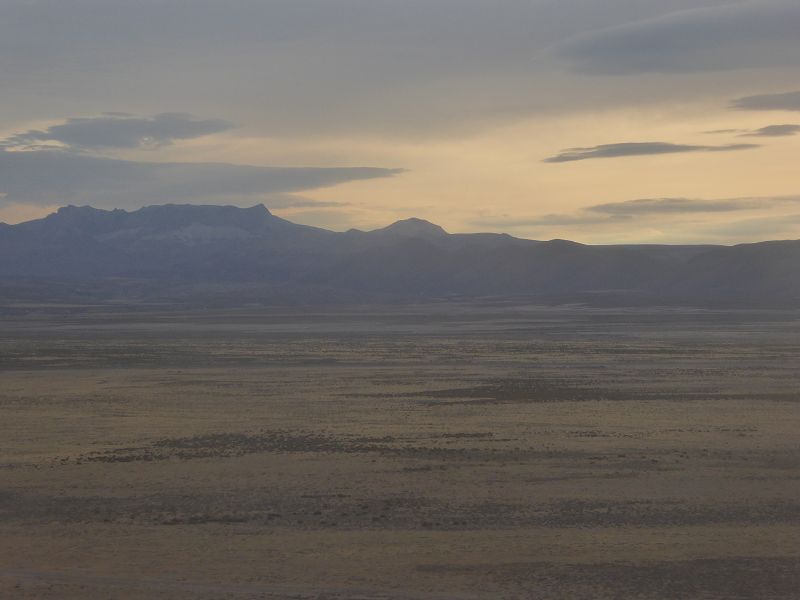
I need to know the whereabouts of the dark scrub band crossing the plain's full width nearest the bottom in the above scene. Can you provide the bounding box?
[0,487,800,531]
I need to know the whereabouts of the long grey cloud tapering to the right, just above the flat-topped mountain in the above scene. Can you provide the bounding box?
[0,150,402,207]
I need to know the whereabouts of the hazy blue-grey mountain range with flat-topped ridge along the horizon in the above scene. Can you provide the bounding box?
[0,205,800,307]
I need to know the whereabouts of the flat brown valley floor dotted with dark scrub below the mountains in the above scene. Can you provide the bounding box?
[0,303,800,600]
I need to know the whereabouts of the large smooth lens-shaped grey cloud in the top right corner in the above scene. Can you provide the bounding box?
[555,0,800,75]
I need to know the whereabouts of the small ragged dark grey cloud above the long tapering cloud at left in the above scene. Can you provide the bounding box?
[0,113,234,150]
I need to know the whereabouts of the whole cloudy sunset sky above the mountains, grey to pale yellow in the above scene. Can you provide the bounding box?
[0,0,800,244]
